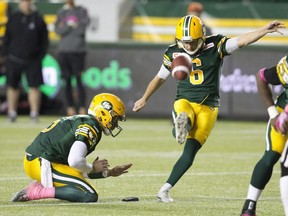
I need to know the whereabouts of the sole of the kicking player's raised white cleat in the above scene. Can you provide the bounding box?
[175,112,188,144]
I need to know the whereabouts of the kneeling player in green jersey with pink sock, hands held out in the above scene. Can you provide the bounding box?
[12,93,132,202]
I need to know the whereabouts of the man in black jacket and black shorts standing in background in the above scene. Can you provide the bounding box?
[4,0,49,122]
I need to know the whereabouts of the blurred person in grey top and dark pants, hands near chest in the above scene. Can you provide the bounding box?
[55,0,90,115]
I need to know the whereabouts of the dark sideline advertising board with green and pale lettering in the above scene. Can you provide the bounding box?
[0,44,286,119]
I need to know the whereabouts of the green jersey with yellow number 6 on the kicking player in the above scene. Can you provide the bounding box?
[163,34,229,107]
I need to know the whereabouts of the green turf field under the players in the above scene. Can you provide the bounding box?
[0,116,284,216]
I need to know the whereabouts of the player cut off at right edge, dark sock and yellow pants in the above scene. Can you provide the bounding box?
[241,55,288,216]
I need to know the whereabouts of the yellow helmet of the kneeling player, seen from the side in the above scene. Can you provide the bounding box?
[88,93,126,137]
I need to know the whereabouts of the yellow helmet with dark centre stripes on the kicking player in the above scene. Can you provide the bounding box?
[175,15,206,55]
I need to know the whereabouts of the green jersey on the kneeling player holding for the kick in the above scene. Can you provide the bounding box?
[26,115,102,165]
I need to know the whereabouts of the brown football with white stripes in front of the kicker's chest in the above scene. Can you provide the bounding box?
[171,53,192,80]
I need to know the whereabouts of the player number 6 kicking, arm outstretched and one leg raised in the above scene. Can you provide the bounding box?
[133,15,284,202]
